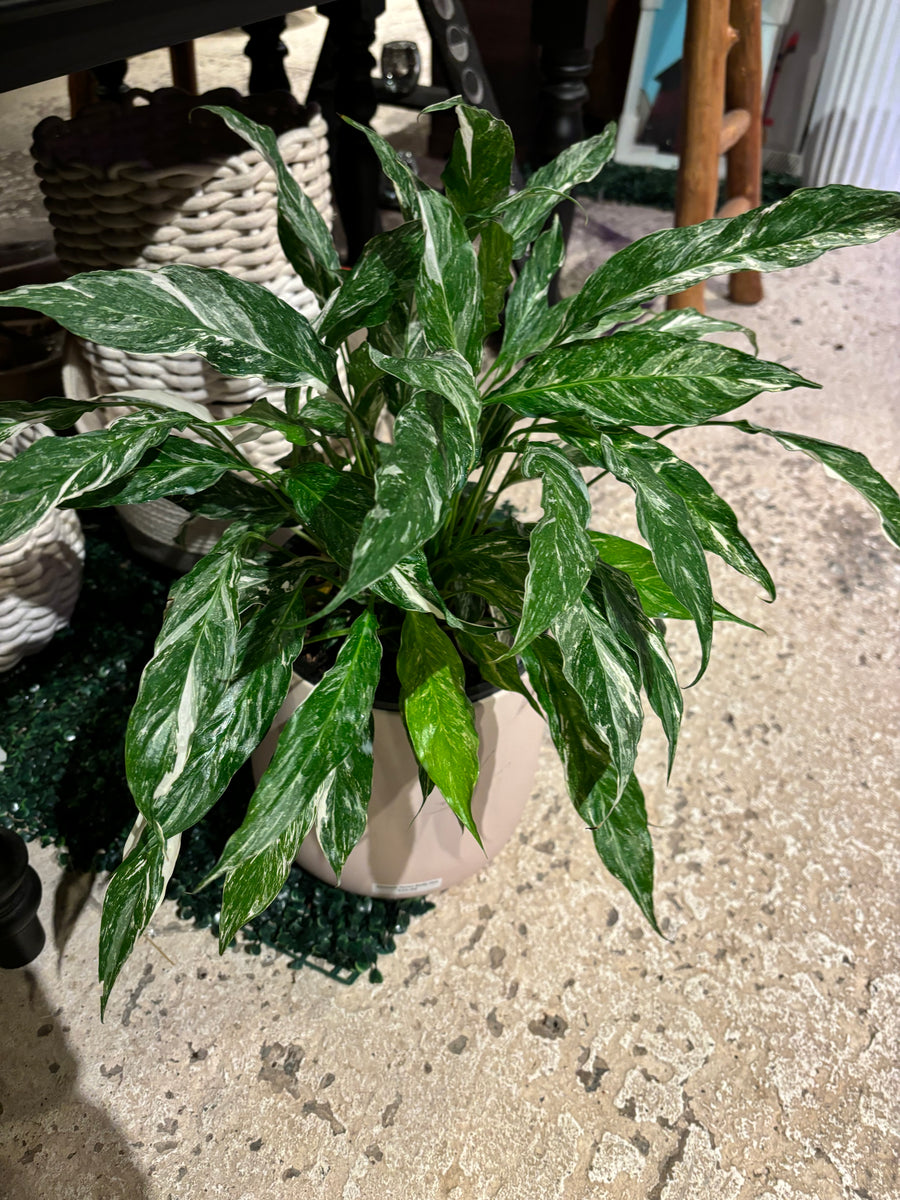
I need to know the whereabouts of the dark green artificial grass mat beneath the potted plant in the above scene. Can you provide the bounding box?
[0,511,433,983]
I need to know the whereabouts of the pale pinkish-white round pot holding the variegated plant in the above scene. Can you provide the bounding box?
[253,679,545,899]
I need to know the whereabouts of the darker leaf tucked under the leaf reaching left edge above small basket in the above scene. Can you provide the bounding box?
[62,437,240,509]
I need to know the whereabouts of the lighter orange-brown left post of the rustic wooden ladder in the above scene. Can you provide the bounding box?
[666,0,734,312]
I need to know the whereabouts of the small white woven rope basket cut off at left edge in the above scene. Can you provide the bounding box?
[0,425,84,671]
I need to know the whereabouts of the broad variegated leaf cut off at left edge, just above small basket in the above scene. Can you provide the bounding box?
[0,410,191,545]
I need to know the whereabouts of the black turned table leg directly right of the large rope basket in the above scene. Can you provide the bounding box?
[307,0,384,263]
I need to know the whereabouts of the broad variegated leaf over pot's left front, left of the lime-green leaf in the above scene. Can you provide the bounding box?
[205,612,382,882]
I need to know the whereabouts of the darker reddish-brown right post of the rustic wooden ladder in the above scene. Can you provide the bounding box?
[725,0,762,304]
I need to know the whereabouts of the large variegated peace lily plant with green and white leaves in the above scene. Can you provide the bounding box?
[0,100,900,1003]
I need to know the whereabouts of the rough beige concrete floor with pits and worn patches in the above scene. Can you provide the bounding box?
[0,4,900,1200]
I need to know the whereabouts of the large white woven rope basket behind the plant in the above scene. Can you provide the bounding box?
[31,88,334,569]
